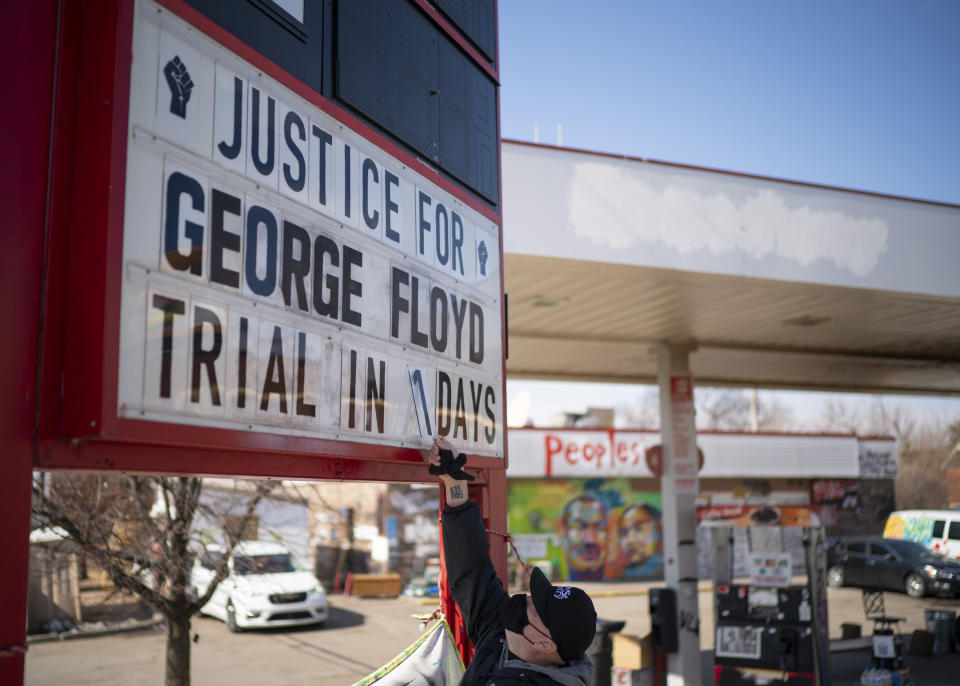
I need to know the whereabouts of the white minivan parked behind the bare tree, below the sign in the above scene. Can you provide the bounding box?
[190,541,328,632]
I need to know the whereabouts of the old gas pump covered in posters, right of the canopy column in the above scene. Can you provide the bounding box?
[711,525,830,686]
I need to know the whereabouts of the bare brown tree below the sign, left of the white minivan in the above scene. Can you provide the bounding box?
[33,474,273,686]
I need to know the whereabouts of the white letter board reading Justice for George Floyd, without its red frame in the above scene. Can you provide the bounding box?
[118,0,504,456]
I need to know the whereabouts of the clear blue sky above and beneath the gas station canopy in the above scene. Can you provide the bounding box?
[498,0,960,430]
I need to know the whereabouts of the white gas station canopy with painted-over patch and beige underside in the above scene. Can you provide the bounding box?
[502,141,960,395]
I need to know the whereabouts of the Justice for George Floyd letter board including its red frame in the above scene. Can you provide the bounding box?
[35,0,506,480]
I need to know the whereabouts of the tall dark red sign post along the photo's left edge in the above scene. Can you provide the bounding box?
[0,0,58,684]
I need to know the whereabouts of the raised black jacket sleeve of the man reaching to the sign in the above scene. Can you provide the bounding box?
[443,502,509,645]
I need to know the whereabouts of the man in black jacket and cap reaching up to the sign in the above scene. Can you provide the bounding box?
[424,438,597,686]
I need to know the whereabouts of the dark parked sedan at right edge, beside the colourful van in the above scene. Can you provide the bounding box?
[827,538,960,598]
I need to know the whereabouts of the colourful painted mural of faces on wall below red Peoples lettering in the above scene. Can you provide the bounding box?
[507,478,663,581]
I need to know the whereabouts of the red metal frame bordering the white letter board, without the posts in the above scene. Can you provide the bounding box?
[34,0,507,482]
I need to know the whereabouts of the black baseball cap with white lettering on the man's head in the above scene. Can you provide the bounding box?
[530,567,597,662]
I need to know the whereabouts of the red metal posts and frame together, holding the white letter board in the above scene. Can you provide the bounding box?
[7,0,507,684]
